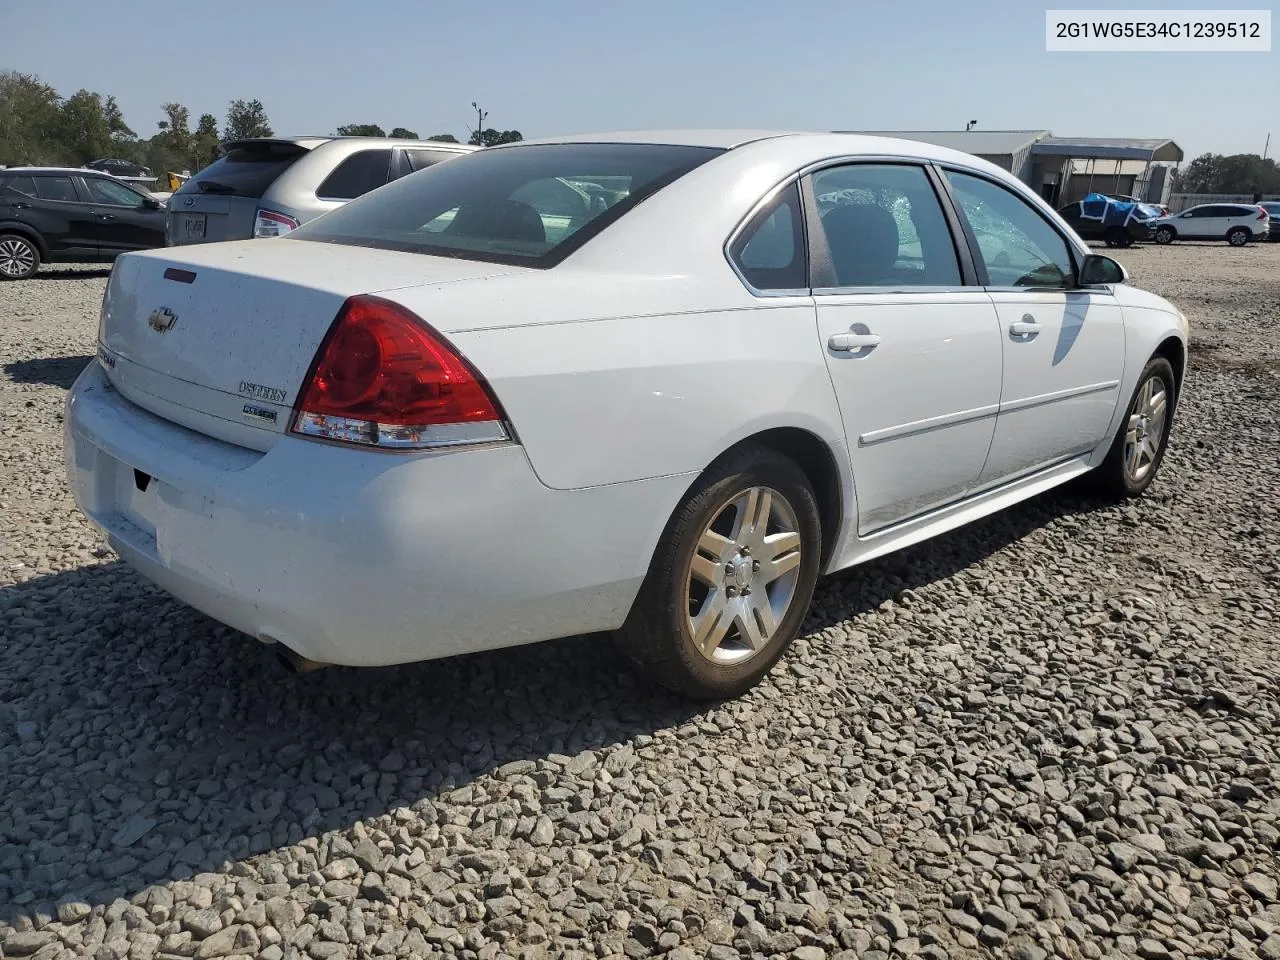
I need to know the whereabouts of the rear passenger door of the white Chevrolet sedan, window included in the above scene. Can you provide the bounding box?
[809,163,1002,535]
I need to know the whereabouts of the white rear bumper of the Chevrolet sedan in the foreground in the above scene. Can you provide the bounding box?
[65,364,689,666]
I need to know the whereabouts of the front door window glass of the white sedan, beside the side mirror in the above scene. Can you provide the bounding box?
[947,170,1075,288]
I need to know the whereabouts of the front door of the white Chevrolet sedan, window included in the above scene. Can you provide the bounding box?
[946,170,1125,486]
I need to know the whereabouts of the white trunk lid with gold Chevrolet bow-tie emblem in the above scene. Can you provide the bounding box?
[99,238,518,451]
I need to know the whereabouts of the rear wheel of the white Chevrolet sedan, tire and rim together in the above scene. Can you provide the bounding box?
[614,445,822,700]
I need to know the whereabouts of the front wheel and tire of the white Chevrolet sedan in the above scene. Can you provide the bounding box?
[1094,357,1178,499]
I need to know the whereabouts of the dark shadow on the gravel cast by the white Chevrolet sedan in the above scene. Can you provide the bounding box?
[0,488,1121,919]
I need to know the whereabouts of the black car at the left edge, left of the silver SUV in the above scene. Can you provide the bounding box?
[0,166,168,280]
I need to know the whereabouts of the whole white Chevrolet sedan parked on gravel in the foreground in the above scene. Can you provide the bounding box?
[65,131,1187,698]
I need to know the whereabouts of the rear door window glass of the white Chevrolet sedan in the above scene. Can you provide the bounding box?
[813,164,961,287]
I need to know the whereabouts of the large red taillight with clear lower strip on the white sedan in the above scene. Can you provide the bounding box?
[293,294,509,449]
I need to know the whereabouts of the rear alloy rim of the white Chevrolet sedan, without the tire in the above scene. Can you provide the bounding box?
[685,486,801,664]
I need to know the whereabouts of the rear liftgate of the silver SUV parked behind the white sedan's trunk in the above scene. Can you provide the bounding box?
[169,140,308,246]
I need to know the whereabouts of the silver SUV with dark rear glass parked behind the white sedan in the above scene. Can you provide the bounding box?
[168,137,477,246]
